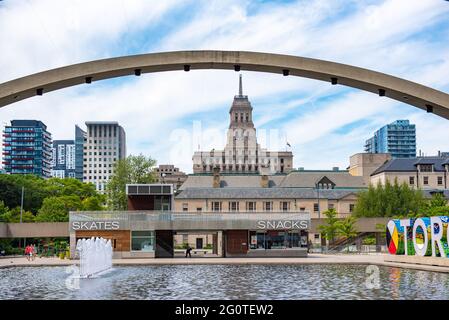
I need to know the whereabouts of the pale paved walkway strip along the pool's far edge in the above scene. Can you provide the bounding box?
[0,253,449,273]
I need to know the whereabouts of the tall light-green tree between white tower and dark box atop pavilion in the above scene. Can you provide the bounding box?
[106,154,157,210]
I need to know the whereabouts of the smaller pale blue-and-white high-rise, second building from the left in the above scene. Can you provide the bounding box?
[51,140,75,179]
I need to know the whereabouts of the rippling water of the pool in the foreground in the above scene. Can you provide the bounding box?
[0,265,449,300]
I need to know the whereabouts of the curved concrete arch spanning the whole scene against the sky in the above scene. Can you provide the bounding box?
[0,50,449,119]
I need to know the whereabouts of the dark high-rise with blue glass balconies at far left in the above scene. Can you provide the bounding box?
[3,120,52,178]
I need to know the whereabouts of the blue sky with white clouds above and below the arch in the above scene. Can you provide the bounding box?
[0,0,449,173]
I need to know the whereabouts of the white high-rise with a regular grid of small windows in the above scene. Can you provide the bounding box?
[83,121,126,192]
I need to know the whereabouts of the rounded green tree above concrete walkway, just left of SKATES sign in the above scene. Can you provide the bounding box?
[35,195,82,222]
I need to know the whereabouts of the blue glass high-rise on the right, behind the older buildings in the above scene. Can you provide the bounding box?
[365,120,416,158]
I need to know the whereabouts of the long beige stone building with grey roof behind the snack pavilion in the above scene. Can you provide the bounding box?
[174,168,366,247]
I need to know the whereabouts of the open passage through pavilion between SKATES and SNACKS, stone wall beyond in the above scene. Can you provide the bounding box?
[173,230,223,258]
